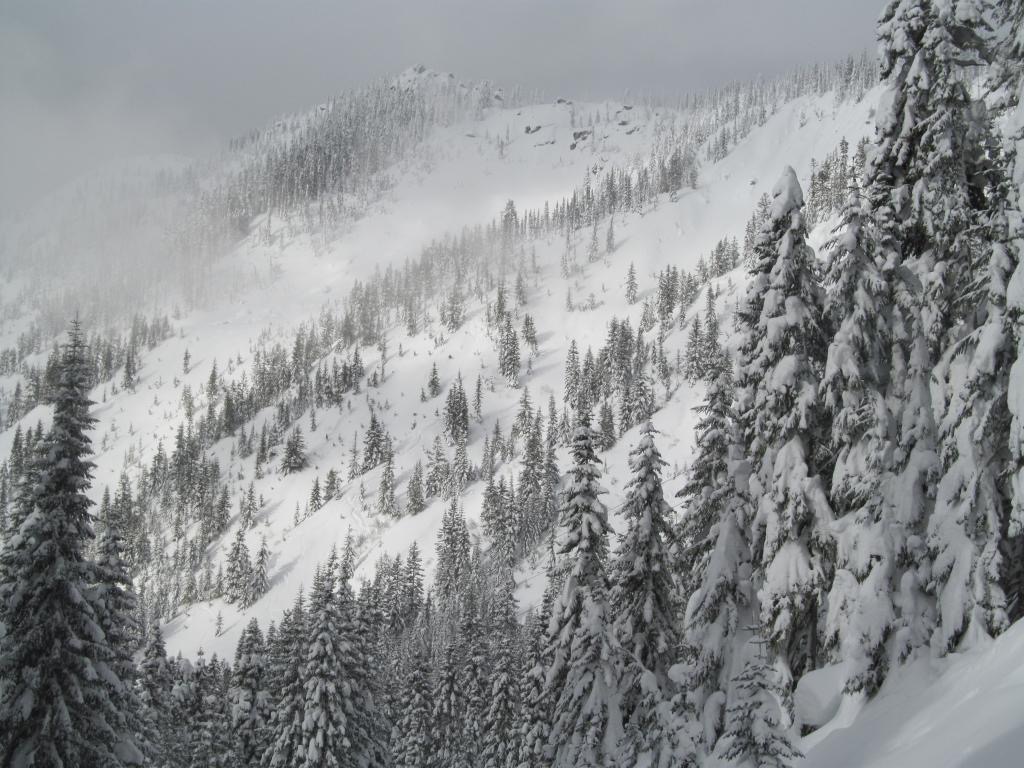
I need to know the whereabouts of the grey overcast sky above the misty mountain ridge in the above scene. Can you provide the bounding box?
[0,0,882,208]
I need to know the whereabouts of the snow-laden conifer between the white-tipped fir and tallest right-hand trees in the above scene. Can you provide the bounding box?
[822,182,902,694]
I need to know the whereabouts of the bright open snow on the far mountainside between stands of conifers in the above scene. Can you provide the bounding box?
[0,78,877,656]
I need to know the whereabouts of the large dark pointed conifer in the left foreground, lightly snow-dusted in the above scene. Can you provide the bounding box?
[0,322,141,766]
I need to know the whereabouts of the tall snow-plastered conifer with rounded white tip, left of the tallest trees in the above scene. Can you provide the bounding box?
[737,168,834,691]
